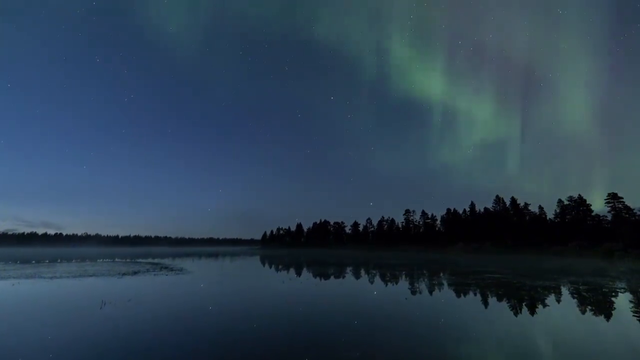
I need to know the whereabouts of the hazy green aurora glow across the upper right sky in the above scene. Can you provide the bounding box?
[135,0,640,208]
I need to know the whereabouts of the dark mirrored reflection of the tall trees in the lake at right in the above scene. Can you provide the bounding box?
[260,252,640,322]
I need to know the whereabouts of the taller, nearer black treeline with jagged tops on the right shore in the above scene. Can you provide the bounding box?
[260,192,640,252]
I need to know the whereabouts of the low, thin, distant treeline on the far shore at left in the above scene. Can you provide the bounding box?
[0,232,259,247]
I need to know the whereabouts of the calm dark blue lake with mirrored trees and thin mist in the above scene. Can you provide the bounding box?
[0,248,640,360]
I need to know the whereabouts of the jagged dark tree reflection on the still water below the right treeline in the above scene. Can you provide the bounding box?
[260,255,640,322]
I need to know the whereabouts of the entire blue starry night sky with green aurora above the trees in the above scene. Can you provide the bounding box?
[0,0,640,237]
